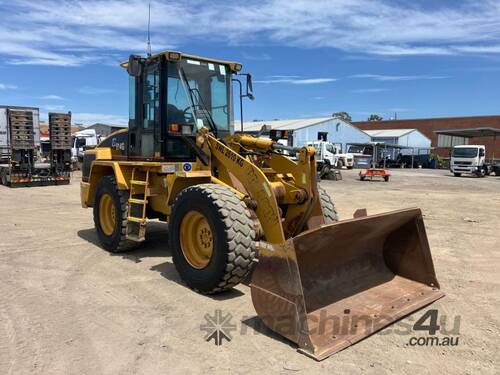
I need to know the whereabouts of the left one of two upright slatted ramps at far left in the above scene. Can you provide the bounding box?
[8,110,35,150]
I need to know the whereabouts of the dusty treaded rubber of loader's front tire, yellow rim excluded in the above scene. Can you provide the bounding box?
[169,184,257,294]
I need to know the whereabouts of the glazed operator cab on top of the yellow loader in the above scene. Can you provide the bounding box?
[121,51,251,161]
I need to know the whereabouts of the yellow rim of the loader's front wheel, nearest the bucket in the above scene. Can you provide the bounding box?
[179,211,214,269]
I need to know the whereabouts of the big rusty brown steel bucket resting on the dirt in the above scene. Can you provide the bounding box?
[251,209,444,360]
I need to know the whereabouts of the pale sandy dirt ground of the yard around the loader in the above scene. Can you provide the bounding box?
[0,170,500,374]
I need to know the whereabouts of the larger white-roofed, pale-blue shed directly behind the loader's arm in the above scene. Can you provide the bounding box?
[243,117,371,152]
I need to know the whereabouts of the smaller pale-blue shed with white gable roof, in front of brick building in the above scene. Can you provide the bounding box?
[365,129,431,155]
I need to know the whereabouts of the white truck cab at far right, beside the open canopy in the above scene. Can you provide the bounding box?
[450,145,488,177]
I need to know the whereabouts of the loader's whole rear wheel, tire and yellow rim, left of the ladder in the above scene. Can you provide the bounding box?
[94,176,138,253]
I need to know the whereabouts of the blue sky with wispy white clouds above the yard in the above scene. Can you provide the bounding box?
[0,0,500,124]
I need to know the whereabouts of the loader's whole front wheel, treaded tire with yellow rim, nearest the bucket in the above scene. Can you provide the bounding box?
[169,184,257,294]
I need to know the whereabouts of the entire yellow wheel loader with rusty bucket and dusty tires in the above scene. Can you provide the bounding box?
[81,51,443,360]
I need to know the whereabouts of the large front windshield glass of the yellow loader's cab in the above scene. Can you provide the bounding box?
[167,59,231,135]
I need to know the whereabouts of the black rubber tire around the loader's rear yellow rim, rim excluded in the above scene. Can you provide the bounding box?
[94,176,138,253]
